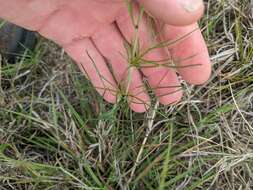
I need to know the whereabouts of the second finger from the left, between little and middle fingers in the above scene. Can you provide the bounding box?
[92,24,149,112]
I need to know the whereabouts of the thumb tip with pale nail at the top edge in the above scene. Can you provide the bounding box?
[138,0,204,26]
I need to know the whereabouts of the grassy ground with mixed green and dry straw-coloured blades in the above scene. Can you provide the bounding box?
[0,0,253,190]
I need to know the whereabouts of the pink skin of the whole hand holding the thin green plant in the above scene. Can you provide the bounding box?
[0,0,211,112]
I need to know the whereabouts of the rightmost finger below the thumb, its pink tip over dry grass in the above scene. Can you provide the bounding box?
[163,24,211,84]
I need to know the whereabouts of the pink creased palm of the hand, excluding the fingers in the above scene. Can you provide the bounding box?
[0,0,123,45]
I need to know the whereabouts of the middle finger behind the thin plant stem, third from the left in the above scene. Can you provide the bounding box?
[117,3,182,105]
